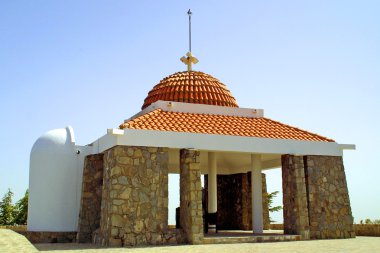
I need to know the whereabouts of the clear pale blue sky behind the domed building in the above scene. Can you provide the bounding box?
[0,0,380,225]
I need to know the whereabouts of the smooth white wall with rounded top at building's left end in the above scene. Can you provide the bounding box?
[28,127,84,231]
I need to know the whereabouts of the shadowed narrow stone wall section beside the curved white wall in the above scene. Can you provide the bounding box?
[77,154,103,243]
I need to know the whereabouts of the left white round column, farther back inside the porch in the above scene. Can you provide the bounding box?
[207,152,218,213]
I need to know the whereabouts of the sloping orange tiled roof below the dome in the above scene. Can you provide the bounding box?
[120,109,334,142]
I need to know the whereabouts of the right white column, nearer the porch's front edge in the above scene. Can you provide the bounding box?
[251,154,263,233]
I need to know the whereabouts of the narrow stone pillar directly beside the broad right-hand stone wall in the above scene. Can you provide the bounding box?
[281,155,309,240]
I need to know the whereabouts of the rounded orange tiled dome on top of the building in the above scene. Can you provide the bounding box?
[141,71,239,109]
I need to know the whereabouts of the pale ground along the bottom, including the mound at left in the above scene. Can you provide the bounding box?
[0,229,380,253]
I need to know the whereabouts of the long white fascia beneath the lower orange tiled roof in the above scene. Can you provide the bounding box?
[92,129,343,156]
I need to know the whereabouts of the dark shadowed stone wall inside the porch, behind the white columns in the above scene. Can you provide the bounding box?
[205,172,269,230]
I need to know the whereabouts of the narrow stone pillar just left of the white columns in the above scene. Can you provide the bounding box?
[180,149,203,244]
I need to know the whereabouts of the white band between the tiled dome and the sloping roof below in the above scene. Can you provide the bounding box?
[124,100,264,122]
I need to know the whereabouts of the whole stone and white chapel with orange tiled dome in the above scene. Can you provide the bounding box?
[28,53,355,246]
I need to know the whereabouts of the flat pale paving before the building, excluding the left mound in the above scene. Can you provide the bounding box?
[35,237,380,253]
